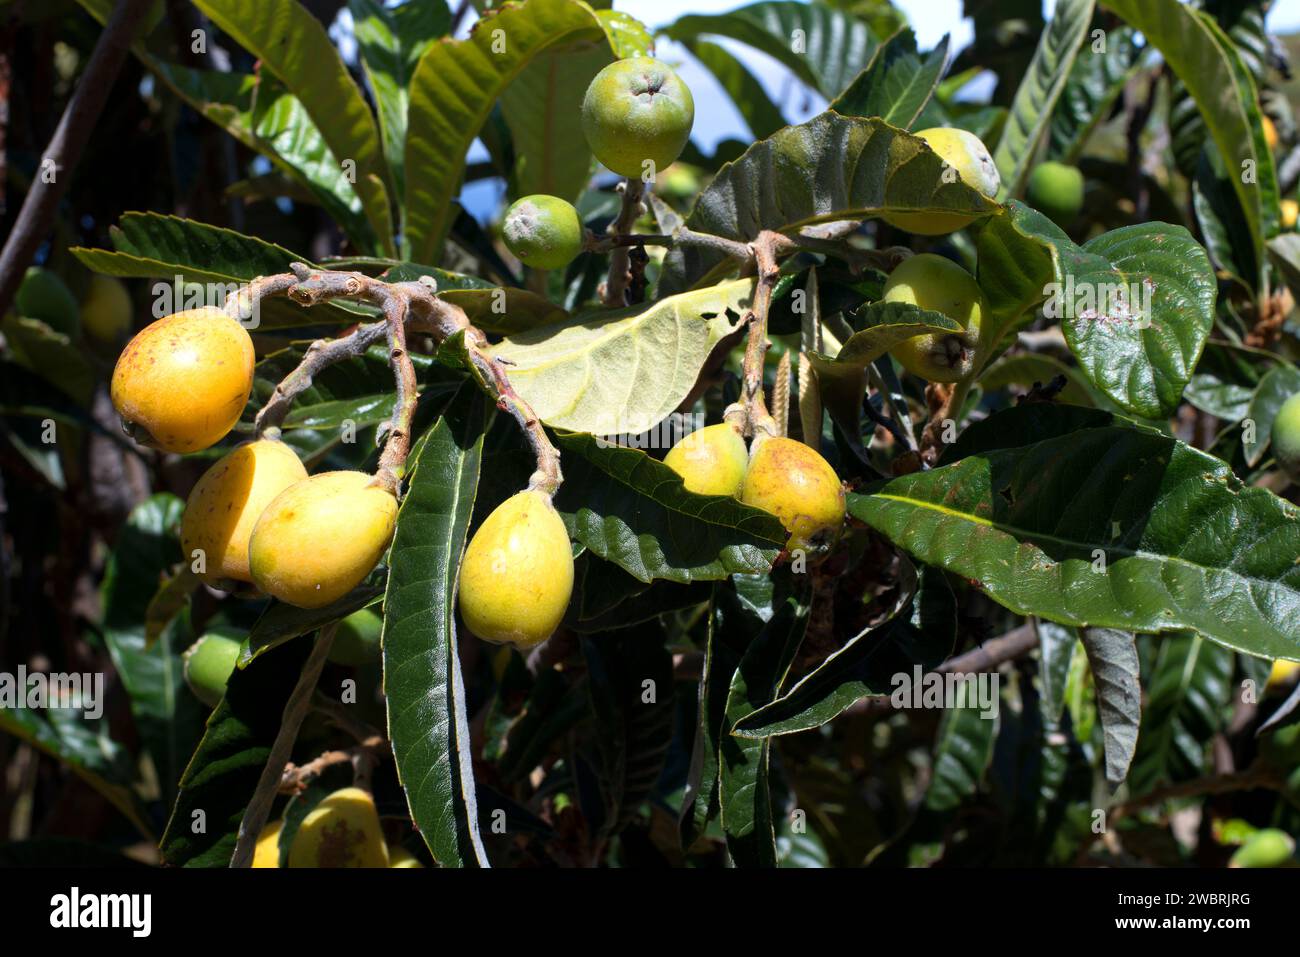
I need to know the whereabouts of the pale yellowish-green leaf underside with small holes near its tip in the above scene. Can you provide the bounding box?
[493,280,754,436]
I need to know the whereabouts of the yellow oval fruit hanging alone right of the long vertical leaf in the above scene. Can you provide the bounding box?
[460,490,573,648]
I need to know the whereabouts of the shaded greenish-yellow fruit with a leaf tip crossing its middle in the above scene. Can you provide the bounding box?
[884,252,988,382]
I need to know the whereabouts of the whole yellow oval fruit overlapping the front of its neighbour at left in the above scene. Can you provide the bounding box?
[248,472,398,609]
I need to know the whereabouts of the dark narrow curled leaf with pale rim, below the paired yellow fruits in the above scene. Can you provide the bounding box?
[732,567,957,737]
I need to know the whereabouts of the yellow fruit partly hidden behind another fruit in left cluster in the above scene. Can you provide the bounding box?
[181,438,307,589]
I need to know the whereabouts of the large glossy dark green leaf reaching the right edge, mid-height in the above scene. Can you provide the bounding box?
[849,403,1300,658]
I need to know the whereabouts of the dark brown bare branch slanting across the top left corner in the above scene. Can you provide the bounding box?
[0,0,152,315]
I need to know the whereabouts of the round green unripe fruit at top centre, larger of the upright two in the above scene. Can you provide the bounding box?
[582,56,696,178]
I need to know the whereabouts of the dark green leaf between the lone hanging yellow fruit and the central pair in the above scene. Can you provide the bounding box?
[555,433,789,583]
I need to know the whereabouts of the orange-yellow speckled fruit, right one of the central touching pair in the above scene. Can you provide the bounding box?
[741,436,845,549]
